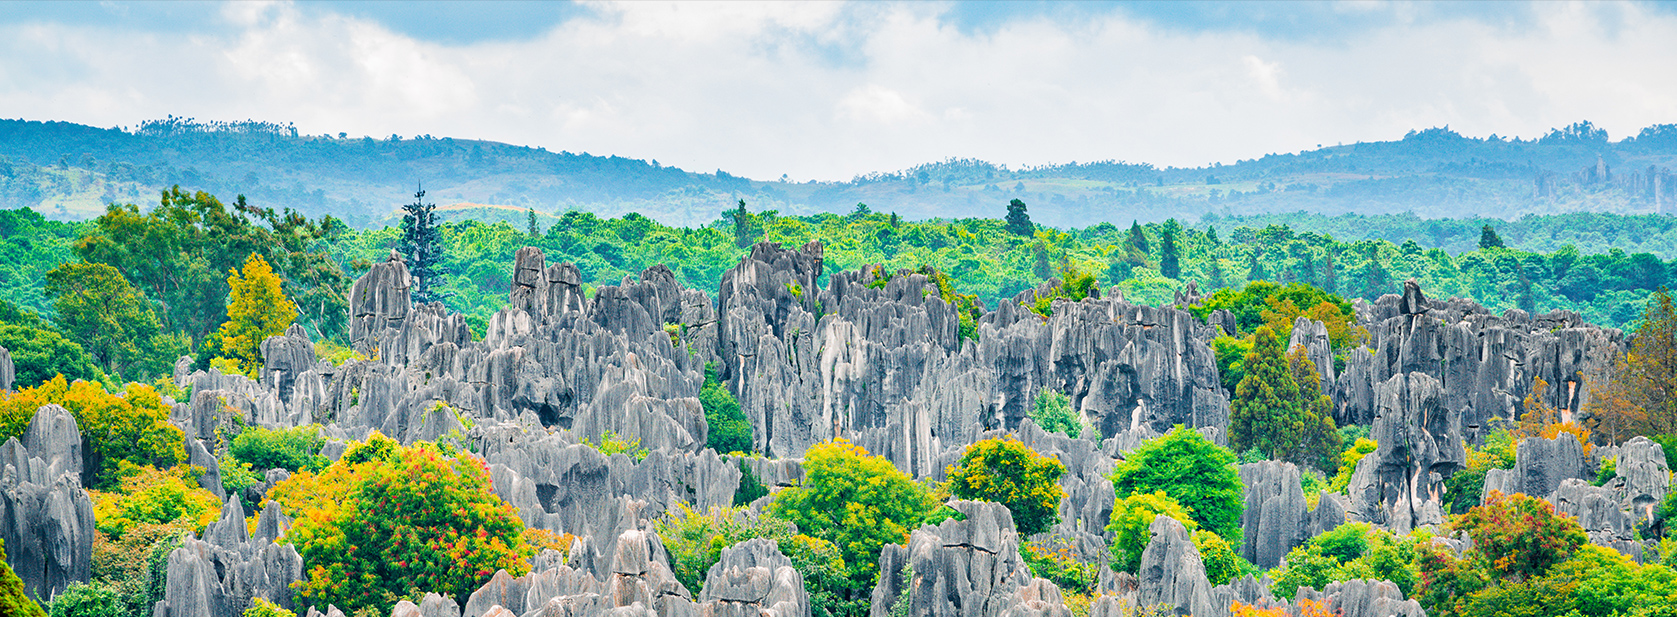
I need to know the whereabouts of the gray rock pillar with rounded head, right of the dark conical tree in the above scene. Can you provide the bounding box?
[1350,372,1467,533]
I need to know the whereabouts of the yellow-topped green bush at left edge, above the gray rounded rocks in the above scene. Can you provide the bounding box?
[0,376,186,488]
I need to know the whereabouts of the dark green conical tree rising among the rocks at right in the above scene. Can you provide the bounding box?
[1229,325,1340,469]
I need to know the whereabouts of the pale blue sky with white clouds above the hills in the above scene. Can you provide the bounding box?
[0,2,1677,181]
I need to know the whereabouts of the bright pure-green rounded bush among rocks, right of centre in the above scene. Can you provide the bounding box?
[1112,426,1246,543]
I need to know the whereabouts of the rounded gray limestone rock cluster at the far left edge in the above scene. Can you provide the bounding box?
[0,406,99,604]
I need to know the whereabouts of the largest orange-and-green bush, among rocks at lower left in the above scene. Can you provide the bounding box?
[268,433,530,612]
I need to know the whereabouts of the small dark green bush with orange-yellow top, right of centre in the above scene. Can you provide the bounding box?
[949,436,1065,537]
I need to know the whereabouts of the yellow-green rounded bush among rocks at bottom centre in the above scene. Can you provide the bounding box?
[770,439,937,588]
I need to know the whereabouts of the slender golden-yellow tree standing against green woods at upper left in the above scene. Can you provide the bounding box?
[215,255,297,377]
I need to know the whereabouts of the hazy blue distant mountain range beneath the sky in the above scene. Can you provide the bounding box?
[0,117,1677,226]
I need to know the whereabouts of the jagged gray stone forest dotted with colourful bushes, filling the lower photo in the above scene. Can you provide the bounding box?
[0,221,1677,617]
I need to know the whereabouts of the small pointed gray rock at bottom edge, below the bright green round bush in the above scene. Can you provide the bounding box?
[1135,516,1218,615]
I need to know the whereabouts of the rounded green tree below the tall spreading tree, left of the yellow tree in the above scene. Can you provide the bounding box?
[45,263,188,381]
